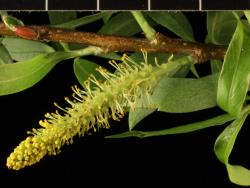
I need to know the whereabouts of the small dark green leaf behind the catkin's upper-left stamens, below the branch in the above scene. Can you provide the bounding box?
[74,58,104,87]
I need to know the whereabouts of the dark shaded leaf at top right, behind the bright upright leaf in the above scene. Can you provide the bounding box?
[207,11,237,45]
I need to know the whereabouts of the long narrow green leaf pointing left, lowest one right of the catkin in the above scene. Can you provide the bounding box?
[106,114,234,138]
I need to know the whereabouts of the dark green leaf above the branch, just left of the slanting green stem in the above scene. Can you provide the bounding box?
[98,12,141,36]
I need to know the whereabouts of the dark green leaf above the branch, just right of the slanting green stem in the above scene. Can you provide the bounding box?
[146,11,194,41]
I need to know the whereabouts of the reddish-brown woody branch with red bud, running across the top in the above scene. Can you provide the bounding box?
[0,23,227,62]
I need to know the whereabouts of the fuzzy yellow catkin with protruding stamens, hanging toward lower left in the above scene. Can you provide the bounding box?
[7,53,191,170]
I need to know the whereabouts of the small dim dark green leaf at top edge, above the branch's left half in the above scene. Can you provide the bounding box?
[48,11,77,25]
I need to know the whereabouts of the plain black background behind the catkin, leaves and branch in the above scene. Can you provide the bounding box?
[0,12,250,187]
